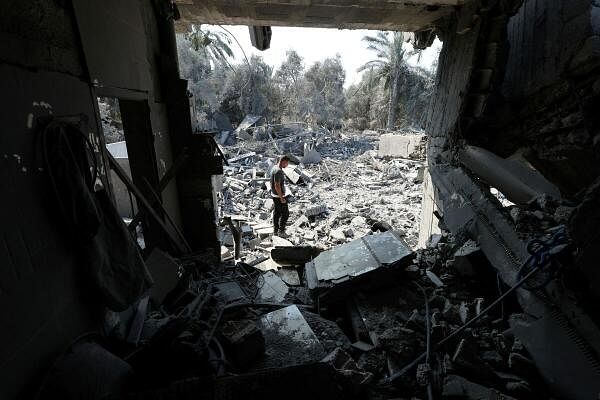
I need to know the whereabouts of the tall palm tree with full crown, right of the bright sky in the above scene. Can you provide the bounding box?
[358,32,416,130]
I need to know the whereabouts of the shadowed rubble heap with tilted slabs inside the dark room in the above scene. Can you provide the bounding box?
[40,231,549,400]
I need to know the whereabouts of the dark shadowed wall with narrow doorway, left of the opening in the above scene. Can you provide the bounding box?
[0,0,215,399]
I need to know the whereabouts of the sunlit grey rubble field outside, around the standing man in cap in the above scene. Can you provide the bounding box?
[220,131,424,268]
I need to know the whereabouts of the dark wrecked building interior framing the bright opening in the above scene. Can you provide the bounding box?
[0,0,600,400]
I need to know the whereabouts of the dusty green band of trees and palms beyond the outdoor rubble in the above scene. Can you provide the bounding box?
[177,28,432,130]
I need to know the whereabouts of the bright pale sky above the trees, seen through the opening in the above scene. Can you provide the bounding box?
[209,26,442,87]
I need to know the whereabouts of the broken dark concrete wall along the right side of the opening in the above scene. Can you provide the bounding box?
[428,0,600,398]
